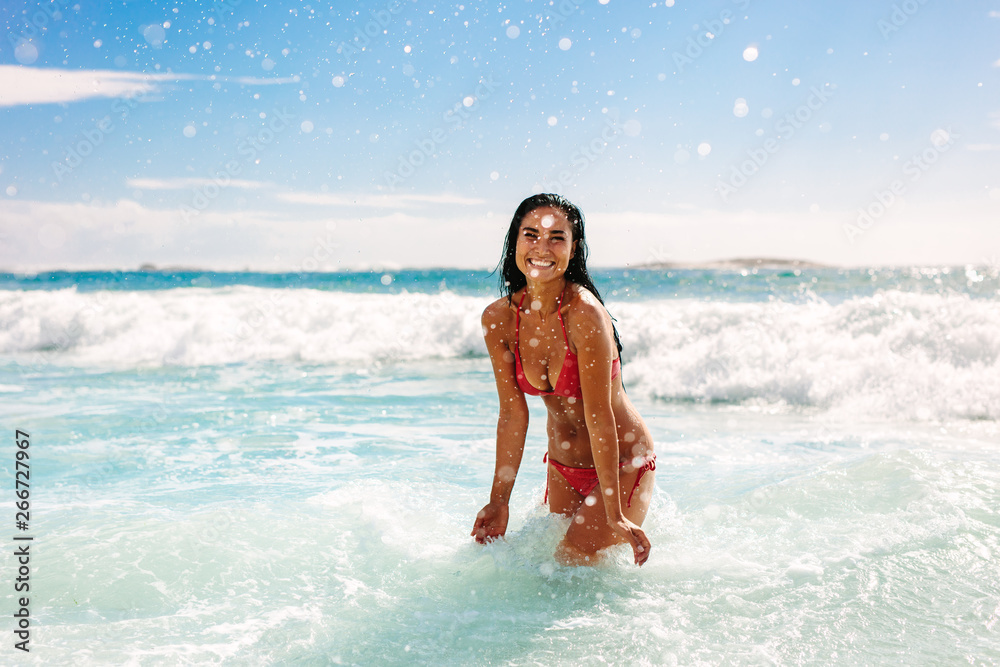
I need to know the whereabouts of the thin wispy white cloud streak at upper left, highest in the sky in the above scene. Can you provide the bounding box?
[0,65,298,107]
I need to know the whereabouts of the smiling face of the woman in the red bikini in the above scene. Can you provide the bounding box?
[516,206,576,282]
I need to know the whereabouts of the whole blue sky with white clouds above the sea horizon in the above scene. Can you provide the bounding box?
[0,0,1000,270]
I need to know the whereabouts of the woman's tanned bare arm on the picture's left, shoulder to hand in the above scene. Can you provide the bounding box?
[472,299,528,543]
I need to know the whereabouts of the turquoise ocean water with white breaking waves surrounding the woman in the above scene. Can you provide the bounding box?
[0,266,1000,665]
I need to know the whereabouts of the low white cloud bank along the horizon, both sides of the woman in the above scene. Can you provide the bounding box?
[0,192,1000,271]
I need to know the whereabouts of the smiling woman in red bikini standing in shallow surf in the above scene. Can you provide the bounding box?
[472,194,656,565]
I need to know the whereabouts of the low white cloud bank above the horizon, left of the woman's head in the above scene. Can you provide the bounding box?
[0,199,504,272]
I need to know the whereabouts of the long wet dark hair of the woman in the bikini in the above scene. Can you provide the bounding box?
[494,193,622,357]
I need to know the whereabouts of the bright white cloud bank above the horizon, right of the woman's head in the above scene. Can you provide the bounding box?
[587,198,1000,266]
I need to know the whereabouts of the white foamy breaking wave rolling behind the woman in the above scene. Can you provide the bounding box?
[0,286,1000,421]
